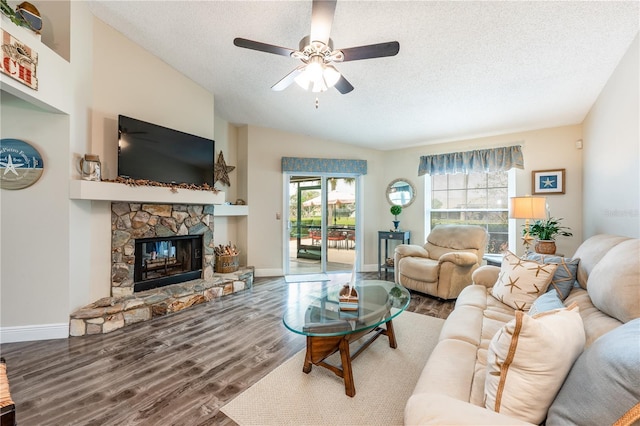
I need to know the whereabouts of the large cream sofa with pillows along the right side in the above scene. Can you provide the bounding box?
[405,235,640,425]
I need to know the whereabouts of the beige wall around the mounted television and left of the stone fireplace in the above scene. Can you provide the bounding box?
[81,18,218,302]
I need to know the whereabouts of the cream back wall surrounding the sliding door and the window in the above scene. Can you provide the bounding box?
[241,121,582,274]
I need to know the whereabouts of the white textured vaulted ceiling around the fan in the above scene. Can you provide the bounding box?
[86,0,640,150]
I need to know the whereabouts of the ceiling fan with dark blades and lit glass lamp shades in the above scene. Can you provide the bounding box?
[233,0,400,95]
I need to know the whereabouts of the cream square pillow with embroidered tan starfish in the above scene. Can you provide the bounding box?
[491,251,558,311]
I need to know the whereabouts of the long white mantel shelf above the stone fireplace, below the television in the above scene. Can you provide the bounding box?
[69,179,248,216]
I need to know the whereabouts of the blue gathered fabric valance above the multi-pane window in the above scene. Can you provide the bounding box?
[418,145,524,176]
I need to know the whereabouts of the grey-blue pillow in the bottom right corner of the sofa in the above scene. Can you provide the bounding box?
[547,318,640,426]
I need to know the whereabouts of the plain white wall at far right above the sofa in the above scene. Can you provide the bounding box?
[583,36,640,238]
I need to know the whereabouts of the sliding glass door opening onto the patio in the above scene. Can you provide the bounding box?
[285,174,358,275]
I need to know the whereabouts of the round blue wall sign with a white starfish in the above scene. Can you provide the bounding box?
[0,139,44,189]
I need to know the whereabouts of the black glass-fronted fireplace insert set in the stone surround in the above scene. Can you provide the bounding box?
[133,235,202,292]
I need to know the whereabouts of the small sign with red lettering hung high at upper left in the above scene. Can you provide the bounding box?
[0,30,38,90]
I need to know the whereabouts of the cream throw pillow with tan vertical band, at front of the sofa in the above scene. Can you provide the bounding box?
[484,303,585,424]
